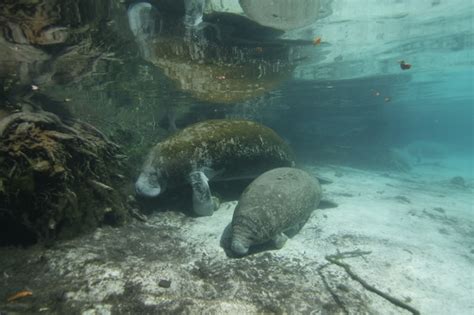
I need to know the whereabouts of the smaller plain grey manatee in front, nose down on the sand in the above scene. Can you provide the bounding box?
[231,167,321,256]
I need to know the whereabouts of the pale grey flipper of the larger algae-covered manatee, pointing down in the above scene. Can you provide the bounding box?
[189,171,215,216]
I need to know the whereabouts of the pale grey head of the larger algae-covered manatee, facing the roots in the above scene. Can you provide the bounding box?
[135,156,166,197]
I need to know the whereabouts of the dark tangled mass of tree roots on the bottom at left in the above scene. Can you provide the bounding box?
[0,110,129,245]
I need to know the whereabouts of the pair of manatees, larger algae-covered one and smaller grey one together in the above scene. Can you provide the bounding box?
[135,119,321,256]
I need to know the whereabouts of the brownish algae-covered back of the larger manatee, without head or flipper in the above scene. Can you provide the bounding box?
[154,119,294,184]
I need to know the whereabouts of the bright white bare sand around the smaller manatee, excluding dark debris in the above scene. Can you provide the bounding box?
[185,166,474,314]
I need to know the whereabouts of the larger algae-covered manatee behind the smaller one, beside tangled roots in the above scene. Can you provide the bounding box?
[135,119,294,216]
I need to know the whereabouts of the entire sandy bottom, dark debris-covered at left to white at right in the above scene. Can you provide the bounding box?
[0,158,474,314]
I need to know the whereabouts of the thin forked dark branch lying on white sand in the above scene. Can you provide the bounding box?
[318,250,420,315]
